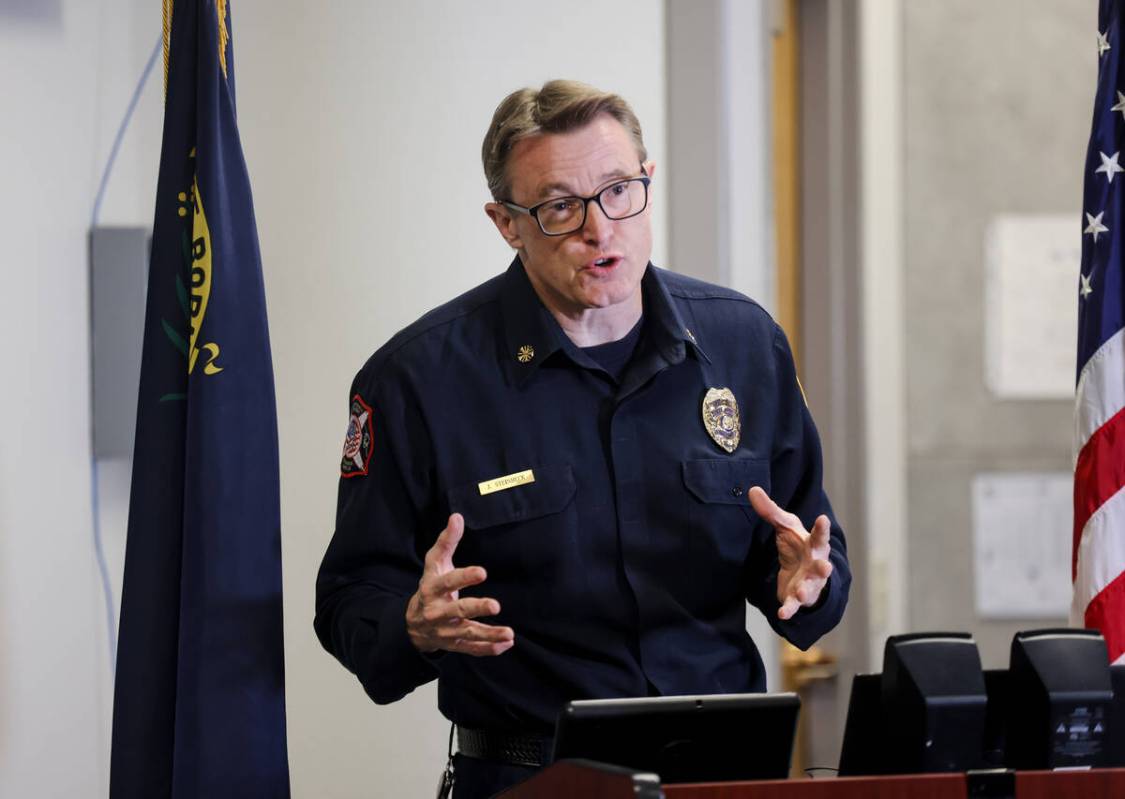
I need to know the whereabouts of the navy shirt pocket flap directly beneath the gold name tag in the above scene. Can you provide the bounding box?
[449,465,576,530]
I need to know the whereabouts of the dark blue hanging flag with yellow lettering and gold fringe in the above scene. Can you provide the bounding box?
[109,0,289,799]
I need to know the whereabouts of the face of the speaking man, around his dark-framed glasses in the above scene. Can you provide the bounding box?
[486,115,653,318]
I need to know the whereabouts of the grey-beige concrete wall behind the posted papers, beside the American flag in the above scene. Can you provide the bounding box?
[902,0,1097,667]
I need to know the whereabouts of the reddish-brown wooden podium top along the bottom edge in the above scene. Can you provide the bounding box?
[498,760,1125,799]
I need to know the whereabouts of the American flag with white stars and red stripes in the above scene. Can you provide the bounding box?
[1071,0,1125,662]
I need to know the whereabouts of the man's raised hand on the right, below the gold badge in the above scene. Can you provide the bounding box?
[749,486,833,620]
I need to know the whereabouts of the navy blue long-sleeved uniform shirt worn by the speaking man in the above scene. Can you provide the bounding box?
[315,259,851,734]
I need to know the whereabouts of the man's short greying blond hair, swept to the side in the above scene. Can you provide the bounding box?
[480,80,648,200]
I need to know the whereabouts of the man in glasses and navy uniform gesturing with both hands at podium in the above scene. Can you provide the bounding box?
[315,81,851,797]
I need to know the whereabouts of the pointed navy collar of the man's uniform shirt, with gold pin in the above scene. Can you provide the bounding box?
[501,255,710,385]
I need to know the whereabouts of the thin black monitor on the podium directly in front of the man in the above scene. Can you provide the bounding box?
[554,693,801,783]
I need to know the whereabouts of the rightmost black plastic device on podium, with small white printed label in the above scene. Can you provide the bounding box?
[1006,629,1114,769]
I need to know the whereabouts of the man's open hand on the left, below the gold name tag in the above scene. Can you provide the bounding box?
[406,513,515,656]
